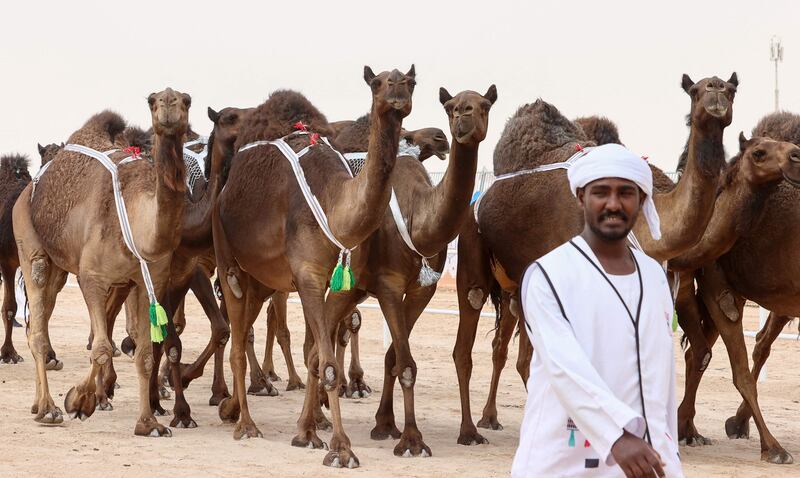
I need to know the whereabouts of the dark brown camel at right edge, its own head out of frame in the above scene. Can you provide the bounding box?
[670,113,800,464]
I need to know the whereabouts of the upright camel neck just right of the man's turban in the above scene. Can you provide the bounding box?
[637,119,725,261]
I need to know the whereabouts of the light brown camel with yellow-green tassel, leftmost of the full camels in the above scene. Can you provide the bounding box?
[13,88,191,436]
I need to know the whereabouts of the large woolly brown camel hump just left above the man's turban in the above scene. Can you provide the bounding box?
[494,98,594,174]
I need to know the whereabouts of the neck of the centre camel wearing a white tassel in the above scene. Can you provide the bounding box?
[410,142,478,256]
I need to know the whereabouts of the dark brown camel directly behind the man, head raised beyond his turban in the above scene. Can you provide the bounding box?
[453,73,738,445]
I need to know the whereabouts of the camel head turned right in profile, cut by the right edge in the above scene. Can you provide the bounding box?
[739,132,800,187]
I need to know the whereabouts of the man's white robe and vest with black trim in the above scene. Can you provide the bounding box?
[511,236,683,478]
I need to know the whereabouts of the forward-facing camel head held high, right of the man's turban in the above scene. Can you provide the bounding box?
[681,72,739,128]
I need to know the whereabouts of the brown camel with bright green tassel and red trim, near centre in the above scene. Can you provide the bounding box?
[213,66,415,468]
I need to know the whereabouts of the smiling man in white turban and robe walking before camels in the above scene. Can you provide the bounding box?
[512,144,683,478]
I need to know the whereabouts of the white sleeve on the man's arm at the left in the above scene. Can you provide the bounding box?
[520,264,645,465]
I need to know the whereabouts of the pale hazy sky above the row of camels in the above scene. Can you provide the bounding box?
[0,0,800,174]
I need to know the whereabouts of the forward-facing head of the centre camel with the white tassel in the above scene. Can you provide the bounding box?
[439,85,497,146]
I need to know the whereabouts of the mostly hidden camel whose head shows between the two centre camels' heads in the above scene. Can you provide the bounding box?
[248,124,450,398]
